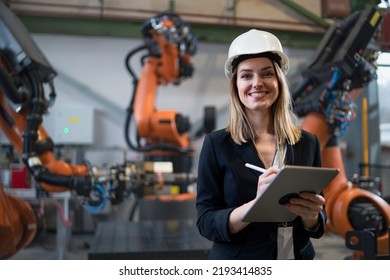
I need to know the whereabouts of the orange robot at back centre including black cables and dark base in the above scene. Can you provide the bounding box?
[125,12,215,199]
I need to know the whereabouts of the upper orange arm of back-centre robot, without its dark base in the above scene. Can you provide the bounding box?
[126,13,196,153]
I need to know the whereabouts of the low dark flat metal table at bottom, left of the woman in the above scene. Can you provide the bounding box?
[88,220,211,260]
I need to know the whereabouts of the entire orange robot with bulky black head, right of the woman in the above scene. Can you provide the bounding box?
[292,8,390,258]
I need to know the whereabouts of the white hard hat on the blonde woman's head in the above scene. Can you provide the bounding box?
[225,29,289,79]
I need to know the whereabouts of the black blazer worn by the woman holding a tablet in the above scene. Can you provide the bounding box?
[196,129,326,259]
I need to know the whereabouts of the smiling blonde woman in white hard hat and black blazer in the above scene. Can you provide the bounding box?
[196,29,326,259]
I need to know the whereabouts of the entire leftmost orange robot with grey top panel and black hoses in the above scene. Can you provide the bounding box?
[0,1,115,258]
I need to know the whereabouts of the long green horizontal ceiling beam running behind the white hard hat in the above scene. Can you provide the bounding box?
[18,15,324,48]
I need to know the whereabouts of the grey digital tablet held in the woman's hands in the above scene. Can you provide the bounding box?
[243,165,340,222]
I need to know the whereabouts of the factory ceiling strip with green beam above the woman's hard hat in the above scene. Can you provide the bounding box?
[0,0,386,48]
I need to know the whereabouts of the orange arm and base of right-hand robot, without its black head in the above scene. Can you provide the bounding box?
[302,106,390,254]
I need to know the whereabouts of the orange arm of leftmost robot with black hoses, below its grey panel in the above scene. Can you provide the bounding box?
[0,54,91,194]
